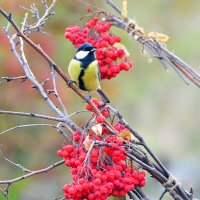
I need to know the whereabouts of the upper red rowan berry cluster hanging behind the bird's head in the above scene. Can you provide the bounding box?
[65,17,132,79]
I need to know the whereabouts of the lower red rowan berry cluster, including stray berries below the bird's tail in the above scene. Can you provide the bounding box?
[57,99,146,200]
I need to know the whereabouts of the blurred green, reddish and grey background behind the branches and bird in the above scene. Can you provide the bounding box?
[0,0,200,200]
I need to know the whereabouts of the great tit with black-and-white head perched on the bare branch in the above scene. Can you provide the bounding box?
[68,43,110,103]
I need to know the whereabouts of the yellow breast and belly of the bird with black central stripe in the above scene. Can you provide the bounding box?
[68,59,99,91]
